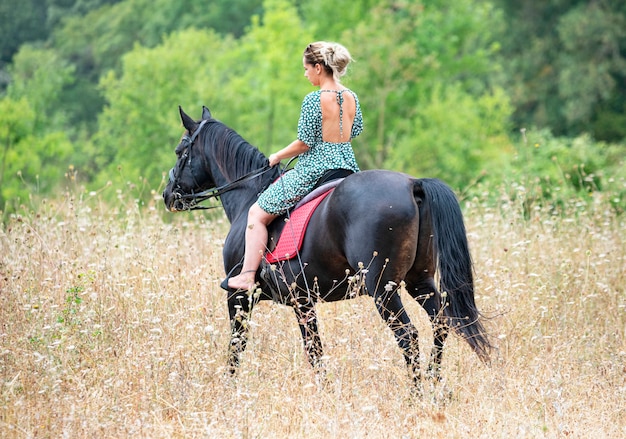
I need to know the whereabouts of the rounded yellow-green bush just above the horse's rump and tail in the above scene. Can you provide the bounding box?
[384,86,512,190]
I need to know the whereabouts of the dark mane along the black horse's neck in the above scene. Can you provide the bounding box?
[204,119,269,181]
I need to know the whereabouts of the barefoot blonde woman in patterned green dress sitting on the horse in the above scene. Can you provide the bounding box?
[228,41,363,290]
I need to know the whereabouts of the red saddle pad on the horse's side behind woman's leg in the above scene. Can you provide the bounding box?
[265,189,333,264]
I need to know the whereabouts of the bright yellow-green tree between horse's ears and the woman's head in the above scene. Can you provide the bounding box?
[219,0,313,149]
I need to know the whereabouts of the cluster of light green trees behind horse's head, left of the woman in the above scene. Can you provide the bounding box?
[96,0,308,197]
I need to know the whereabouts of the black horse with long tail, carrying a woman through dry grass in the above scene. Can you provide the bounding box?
[163,107,491,380]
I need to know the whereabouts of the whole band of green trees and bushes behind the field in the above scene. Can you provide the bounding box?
[0,0,626,215]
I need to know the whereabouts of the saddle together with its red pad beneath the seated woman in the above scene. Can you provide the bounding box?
[265,169,352,264]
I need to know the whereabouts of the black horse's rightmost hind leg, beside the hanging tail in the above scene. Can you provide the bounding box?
[406,278,448,380]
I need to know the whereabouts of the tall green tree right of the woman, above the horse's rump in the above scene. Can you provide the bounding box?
[336,0,510,186]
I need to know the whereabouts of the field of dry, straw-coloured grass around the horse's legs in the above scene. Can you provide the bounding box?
[0,187,626,438]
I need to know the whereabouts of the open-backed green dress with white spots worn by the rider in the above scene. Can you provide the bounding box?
[257,90,363,215]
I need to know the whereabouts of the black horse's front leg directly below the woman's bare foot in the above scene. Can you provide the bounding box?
[228,291,254,374]
